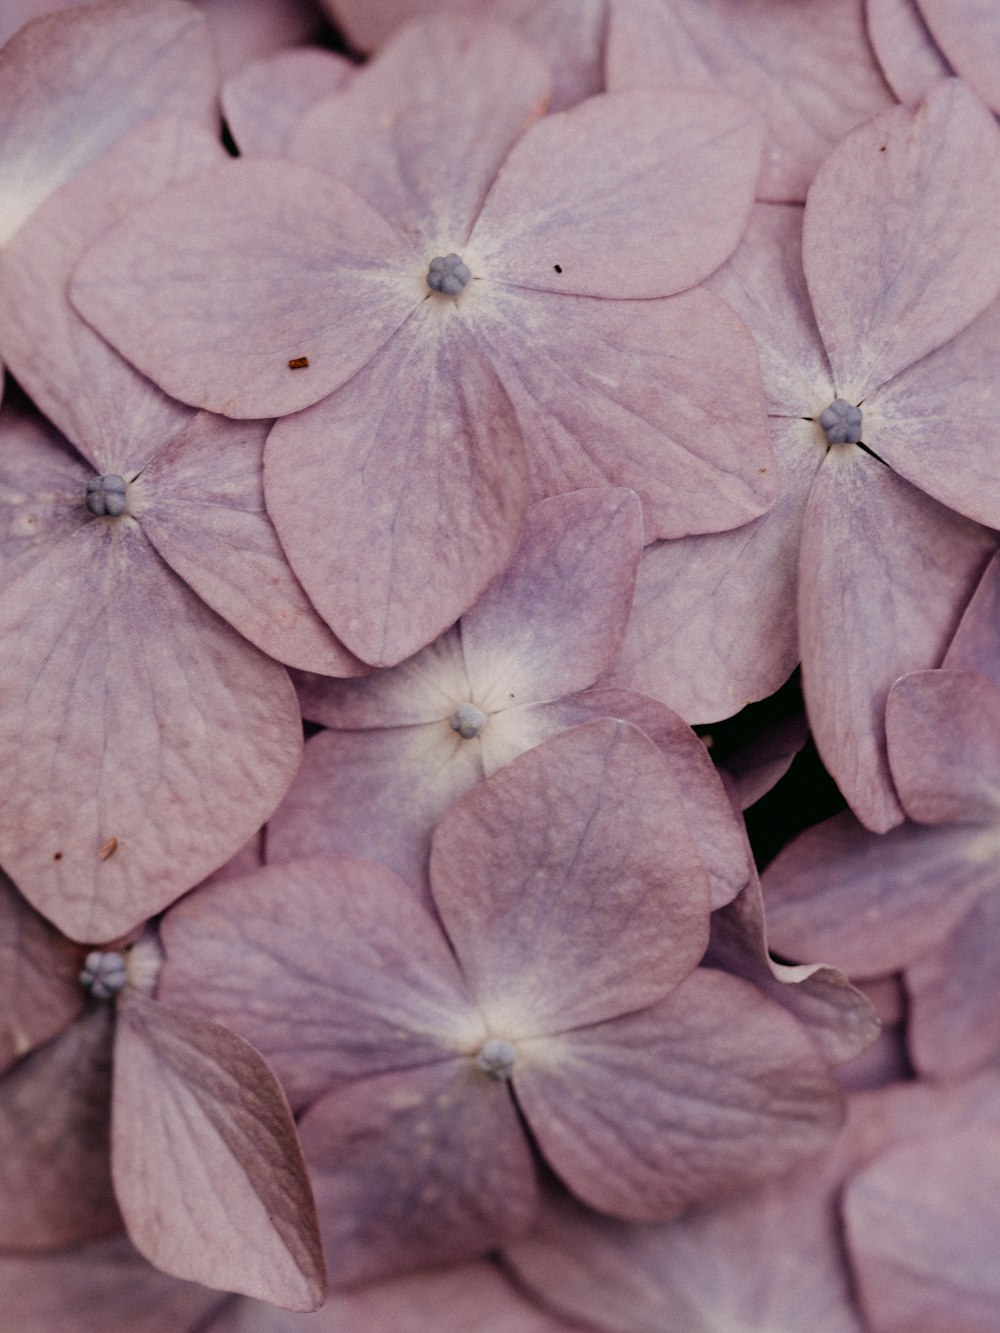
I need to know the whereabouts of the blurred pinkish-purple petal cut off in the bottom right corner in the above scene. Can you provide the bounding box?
[843,1122,1000,1333]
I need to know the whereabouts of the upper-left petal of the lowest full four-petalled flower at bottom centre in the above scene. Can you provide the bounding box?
[157,856,487,1112]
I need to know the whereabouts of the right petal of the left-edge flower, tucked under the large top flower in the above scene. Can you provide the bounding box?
[135,412,368,676]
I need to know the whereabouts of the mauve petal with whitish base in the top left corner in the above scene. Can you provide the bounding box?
[0,0,217,249]
